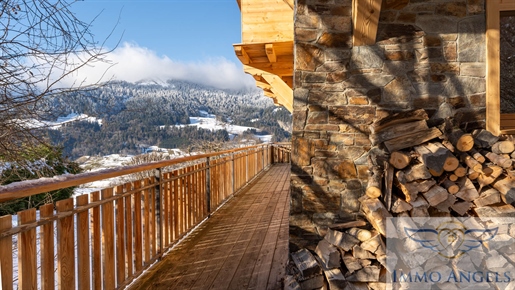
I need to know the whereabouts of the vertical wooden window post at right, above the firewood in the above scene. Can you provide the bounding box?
[486,0,501,136]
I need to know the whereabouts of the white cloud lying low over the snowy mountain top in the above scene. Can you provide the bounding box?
[54,43,255,89]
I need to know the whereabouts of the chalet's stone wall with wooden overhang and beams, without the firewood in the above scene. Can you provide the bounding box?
[234,0,515,288]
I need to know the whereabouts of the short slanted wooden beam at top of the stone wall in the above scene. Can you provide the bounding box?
[352,0,382,46]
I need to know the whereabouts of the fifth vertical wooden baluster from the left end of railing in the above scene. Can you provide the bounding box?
[75,195,91,290]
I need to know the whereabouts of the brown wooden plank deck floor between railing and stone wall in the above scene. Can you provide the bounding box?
[130,164,290,290]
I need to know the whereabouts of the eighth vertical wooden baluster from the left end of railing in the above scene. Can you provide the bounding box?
[116,185,126,285]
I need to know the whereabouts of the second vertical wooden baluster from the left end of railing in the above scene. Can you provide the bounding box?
[17,208,37,289]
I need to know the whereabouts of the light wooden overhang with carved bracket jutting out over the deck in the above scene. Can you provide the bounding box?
[234,0,294,112]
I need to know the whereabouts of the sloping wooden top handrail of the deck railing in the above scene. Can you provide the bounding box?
[0,144,290,202]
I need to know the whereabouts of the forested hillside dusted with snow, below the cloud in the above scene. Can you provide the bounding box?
[43,81,291,158]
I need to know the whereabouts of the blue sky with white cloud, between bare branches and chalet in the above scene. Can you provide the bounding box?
[65,0,252,89]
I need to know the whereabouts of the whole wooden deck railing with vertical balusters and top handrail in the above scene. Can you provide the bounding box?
[0,144,290,290]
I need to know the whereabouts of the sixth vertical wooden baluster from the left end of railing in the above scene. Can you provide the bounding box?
[90,191,102,289]
